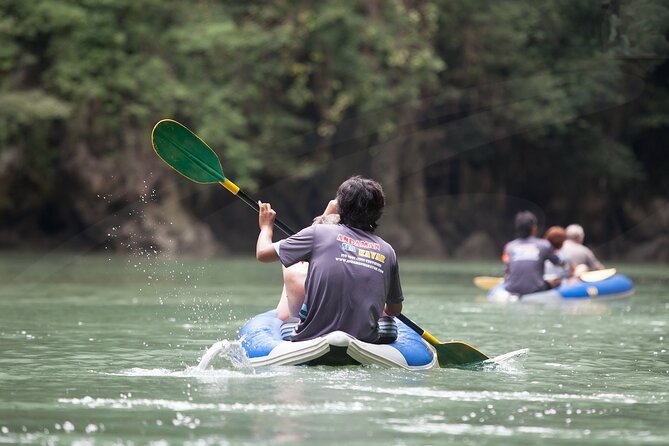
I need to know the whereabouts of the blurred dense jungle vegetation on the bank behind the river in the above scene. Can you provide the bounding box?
[0,0,669,261]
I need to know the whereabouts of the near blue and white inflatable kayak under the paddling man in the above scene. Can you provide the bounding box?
[239,310,437,370]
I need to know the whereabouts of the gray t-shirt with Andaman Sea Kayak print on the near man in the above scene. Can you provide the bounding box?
[278,224,404,342]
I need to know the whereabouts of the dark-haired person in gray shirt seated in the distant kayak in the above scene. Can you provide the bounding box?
[502,211,562,296]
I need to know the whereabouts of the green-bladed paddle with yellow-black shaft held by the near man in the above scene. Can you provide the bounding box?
[151,119,490,367]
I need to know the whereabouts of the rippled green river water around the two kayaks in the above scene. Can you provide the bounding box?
[0,253,669,445]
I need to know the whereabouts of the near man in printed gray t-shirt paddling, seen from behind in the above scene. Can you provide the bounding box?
[256,176,404,342]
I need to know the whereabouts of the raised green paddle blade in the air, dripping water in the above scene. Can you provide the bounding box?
[151,119,225,183]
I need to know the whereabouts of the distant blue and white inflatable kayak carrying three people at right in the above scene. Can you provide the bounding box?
[488,274,634,303]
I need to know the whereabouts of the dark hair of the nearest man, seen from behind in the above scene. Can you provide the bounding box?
[337,175,386,232]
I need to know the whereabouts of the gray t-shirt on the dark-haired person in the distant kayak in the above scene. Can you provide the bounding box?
[504,237,560,295]
